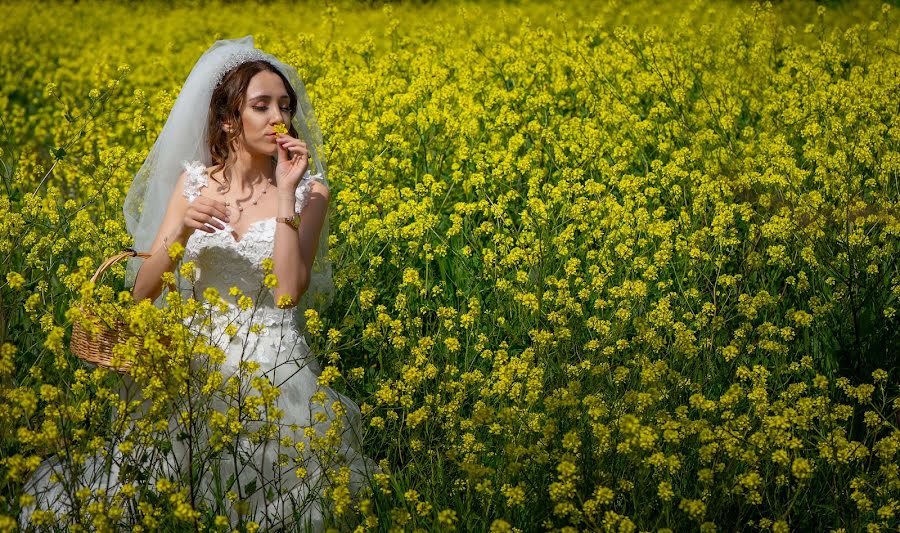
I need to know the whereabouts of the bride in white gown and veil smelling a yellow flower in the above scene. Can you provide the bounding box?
[24,36,375,529]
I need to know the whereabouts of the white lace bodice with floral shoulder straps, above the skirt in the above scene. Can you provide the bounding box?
[183,161,321,308]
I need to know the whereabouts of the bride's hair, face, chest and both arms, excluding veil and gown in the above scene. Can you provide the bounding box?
[133,49,328,308]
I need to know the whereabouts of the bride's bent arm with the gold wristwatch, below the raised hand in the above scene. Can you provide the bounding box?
[272,180,330,307]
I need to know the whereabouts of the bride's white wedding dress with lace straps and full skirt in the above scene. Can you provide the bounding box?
[20,162,377,530]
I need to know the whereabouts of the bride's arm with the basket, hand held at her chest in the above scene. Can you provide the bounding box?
[131,173,228,301]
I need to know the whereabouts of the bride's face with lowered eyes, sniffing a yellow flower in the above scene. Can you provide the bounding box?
[234,70,291,156]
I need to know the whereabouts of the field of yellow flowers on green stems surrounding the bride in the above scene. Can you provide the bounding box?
[0,0,900,532]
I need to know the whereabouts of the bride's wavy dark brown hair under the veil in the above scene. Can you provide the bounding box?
[206,60,298,190]
